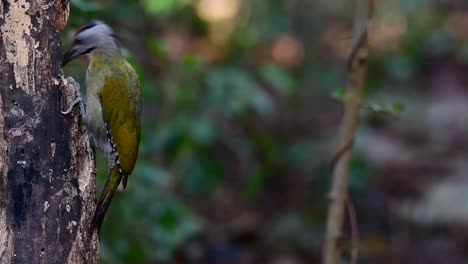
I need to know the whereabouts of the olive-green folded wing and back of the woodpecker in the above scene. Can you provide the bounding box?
[99,60,142,175]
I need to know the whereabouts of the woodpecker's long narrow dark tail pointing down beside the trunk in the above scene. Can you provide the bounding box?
[91,166,122,232]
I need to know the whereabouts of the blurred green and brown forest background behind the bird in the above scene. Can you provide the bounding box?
[62,0,468,264]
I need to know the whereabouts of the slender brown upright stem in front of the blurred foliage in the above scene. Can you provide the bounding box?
[323,0,374,264]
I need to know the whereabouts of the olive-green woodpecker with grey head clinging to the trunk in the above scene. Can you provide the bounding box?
[62,20,142,230]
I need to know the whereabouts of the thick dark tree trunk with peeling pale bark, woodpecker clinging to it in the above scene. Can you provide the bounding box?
[0,0,99,264]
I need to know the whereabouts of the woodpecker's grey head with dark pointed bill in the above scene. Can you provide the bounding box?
[62,20,119,67]
